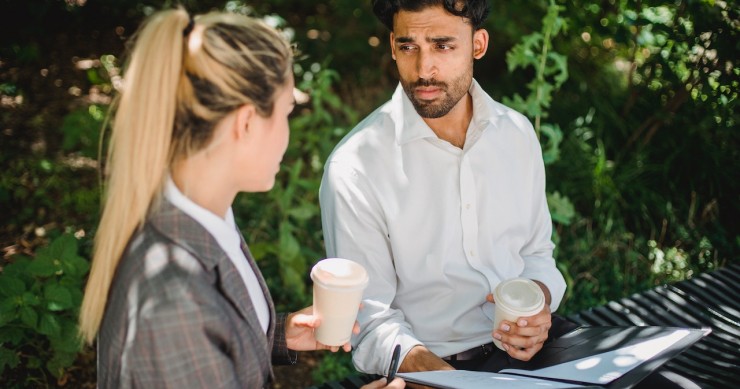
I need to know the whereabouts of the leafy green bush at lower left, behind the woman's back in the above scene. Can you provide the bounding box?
[0,234,90,387]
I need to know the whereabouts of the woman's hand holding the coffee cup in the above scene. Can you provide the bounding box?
[285,306,358,352]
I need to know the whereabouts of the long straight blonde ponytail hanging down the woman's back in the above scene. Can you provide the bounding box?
[80,9,190,343]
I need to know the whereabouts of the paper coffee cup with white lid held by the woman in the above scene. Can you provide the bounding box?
[311,258,368,346]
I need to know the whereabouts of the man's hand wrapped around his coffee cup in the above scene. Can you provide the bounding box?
[486,281,552,361]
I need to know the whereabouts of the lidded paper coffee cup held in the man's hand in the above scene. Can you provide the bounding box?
[493,278,545,350]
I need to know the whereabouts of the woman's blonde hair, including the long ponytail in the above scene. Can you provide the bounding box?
[80,8,292,343]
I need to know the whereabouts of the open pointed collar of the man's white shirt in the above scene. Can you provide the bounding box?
[389,79,505,145]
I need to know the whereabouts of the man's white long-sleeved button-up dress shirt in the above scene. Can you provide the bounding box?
[320,80,566,374]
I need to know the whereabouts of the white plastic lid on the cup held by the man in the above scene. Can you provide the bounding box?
[493,278,545,316]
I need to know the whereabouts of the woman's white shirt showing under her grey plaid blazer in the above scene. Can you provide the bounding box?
[164,177,270,333]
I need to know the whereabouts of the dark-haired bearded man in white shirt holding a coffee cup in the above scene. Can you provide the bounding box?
[320,0,565,374]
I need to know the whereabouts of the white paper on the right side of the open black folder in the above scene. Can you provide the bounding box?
[500,329,689,384]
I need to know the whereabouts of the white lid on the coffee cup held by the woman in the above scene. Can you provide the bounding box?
[311,258,369,289]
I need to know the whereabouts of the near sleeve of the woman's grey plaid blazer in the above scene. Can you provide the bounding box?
[121,288,241,388]
